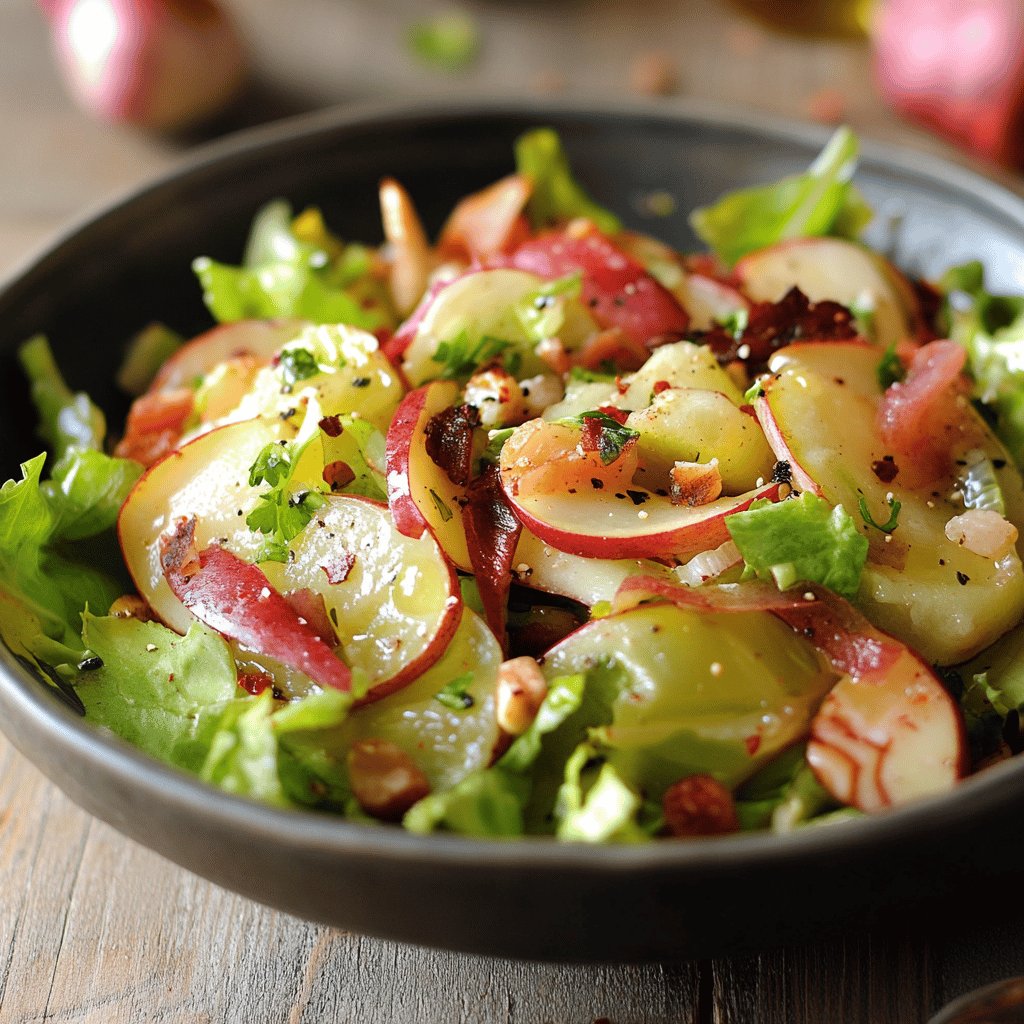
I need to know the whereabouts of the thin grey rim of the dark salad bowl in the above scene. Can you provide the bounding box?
[0,96,1024,873]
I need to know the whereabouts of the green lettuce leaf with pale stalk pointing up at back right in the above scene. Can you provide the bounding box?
[690,127,871,266]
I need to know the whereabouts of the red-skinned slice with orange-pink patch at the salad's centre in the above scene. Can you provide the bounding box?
[500,420,779,559]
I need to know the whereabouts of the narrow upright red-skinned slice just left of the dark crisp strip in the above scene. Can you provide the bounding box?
[387,381,472,572]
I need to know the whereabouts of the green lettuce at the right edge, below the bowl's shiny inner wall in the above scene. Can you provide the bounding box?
[941,262,1024,468]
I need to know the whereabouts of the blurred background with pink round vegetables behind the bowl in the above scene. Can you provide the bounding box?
[8,0,1024,282]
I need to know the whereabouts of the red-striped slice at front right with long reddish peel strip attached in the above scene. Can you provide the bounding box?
[614,577,968,811]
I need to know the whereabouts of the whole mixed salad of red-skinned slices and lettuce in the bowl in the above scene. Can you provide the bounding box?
[6,128,1024,843]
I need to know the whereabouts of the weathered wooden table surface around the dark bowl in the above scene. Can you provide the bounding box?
[0,0,1024,1024]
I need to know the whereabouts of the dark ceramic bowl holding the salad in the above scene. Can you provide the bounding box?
[6,104,1024,959]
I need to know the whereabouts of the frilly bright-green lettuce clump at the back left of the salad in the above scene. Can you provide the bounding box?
[193,200,393,331]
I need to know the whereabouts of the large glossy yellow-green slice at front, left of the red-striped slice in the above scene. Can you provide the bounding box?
[543,602,836,799]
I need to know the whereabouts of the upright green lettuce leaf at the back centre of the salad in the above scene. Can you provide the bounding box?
[515,128,623,234]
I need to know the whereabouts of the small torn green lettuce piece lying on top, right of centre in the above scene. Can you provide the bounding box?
[725,490,868,598]
